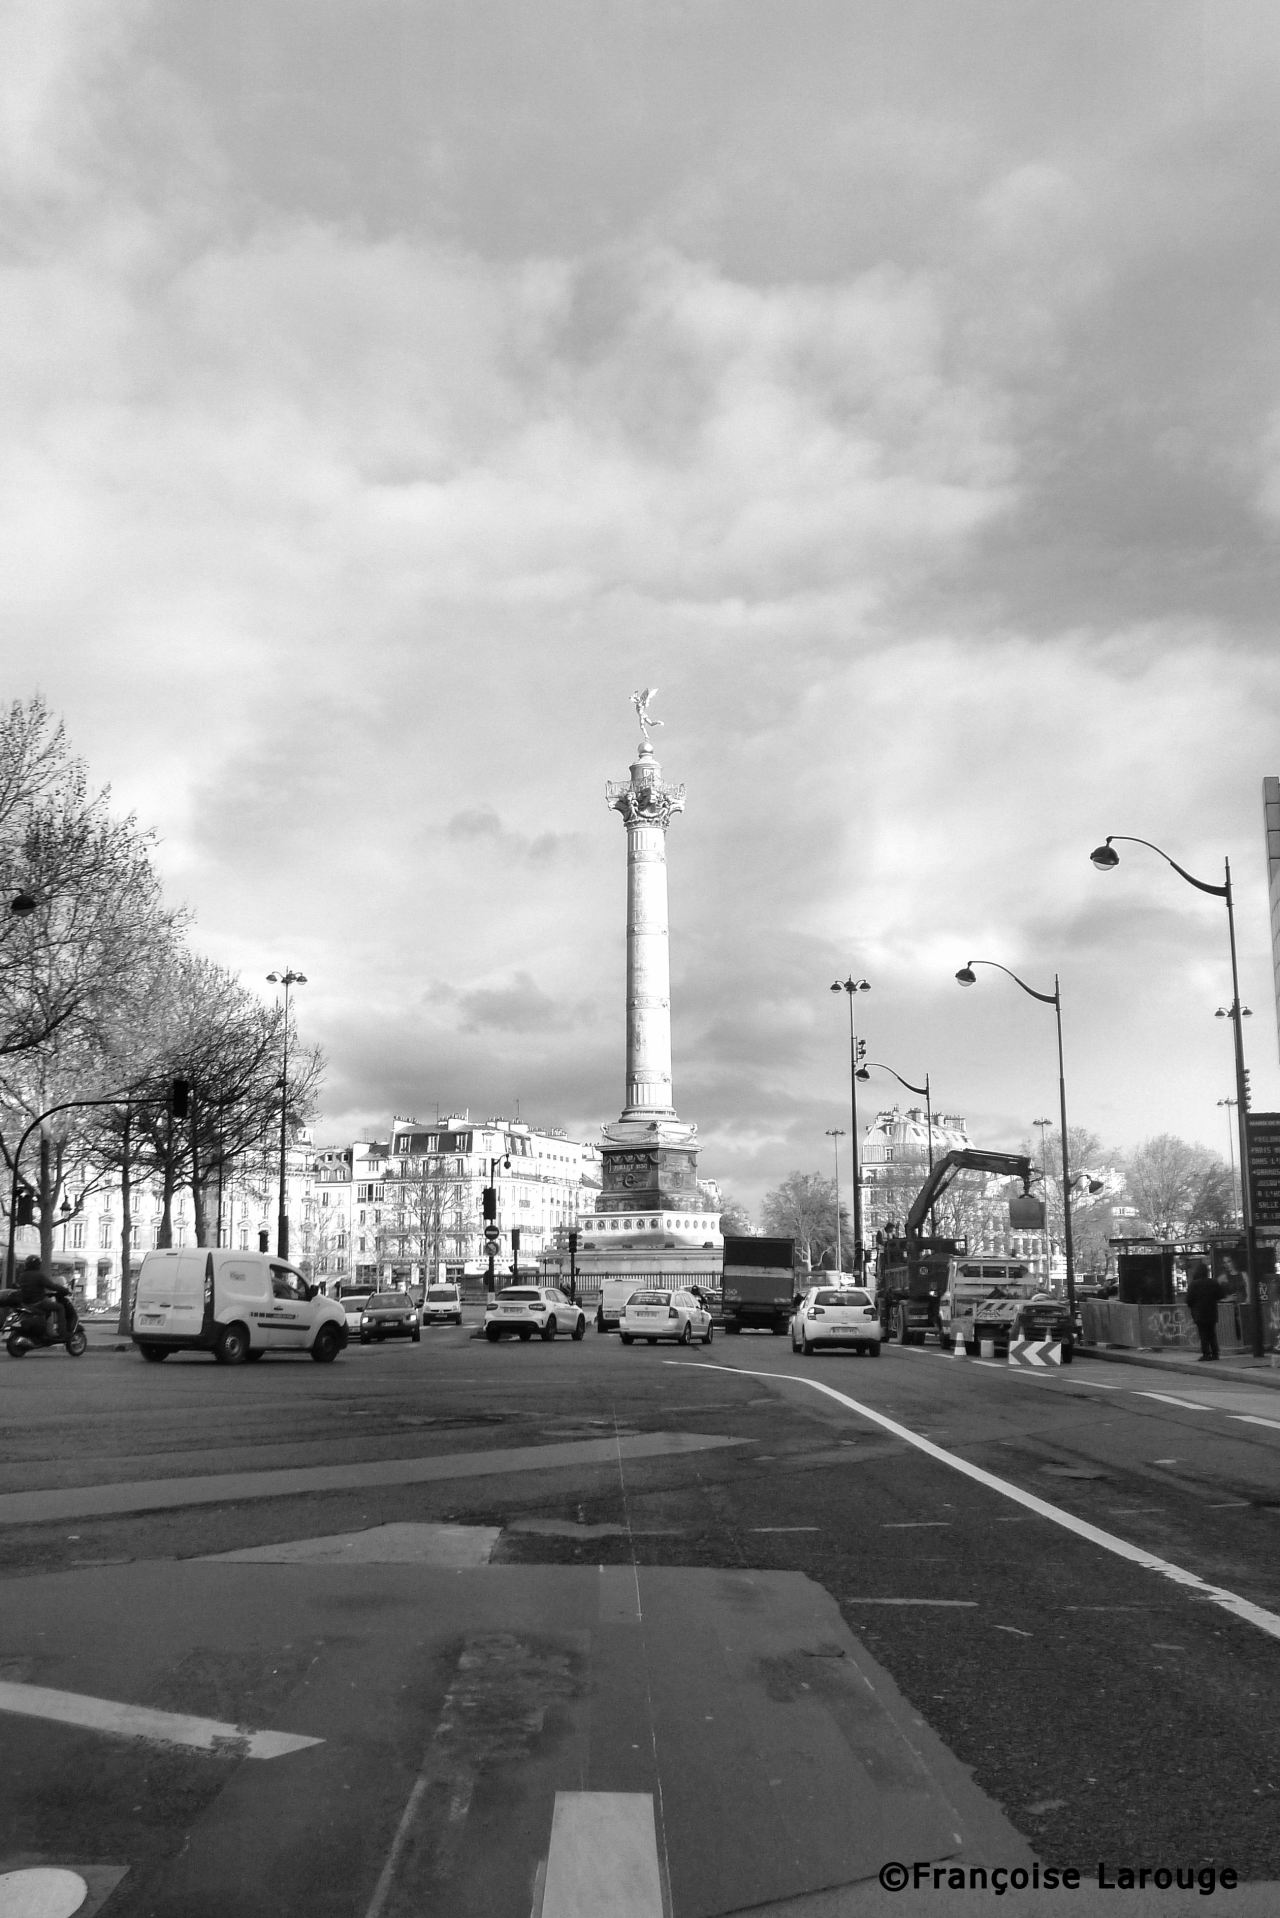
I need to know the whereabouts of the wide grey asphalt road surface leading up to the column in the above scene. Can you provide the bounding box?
[0,1327,1280,1918]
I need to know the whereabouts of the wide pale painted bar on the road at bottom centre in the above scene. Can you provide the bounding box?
[541,1791,662,1918]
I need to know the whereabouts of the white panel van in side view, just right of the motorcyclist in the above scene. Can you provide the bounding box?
[132,1245,347,1366]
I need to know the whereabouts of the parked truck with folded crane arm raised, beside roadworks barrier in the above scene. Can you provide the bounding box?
[875,1145,1075,1358]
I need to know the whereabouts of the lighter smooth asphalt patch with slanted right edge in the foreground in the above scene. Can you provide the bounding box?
[0,1549,1031,1918]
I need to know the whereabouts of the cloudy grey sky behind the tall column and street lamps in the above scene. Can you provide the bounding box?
[0,0,1280,1203]
